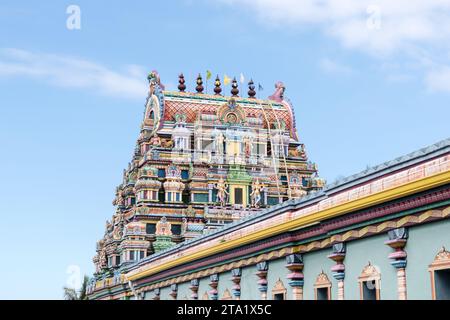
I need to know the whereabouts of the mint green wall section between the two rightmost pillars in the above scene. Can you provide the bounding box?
[344,233,397,300]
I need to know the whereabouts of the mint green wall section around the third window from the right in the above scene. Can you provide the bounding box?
[303,248,337,300]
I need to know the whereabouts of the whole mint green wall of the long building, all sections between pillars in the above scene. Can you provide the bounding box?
[152,215,450,300]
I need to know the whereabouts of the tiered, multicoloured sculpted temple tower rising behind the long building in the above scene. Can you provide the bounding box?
[93,71,324,280]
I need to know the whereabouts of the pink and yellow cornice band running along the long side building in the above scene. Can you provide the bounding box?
[127,158,450,280]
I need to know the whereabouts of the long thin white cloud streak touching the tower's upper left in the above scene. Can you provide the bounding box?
[0,49,146,99]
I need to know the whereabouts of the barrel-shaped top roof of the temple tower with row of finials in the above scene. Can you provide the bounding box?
[145,71,298,141]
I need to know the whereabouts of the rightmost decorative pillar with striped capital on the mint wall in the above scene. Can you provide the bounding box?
[385,228,408,300]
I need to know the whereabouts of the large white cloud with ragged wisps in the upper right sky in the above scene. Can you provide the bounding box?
[221,0,450,91]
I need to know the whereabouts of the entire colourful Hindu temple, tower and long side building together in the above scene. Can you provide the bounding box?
[87,71,450,300]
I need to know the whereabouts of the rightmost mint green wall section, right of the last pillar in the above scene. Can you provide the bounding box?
[405,220,450,299]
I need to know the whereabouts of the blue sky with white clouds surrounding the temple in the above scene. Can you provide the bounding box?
[0,0,450,299]
